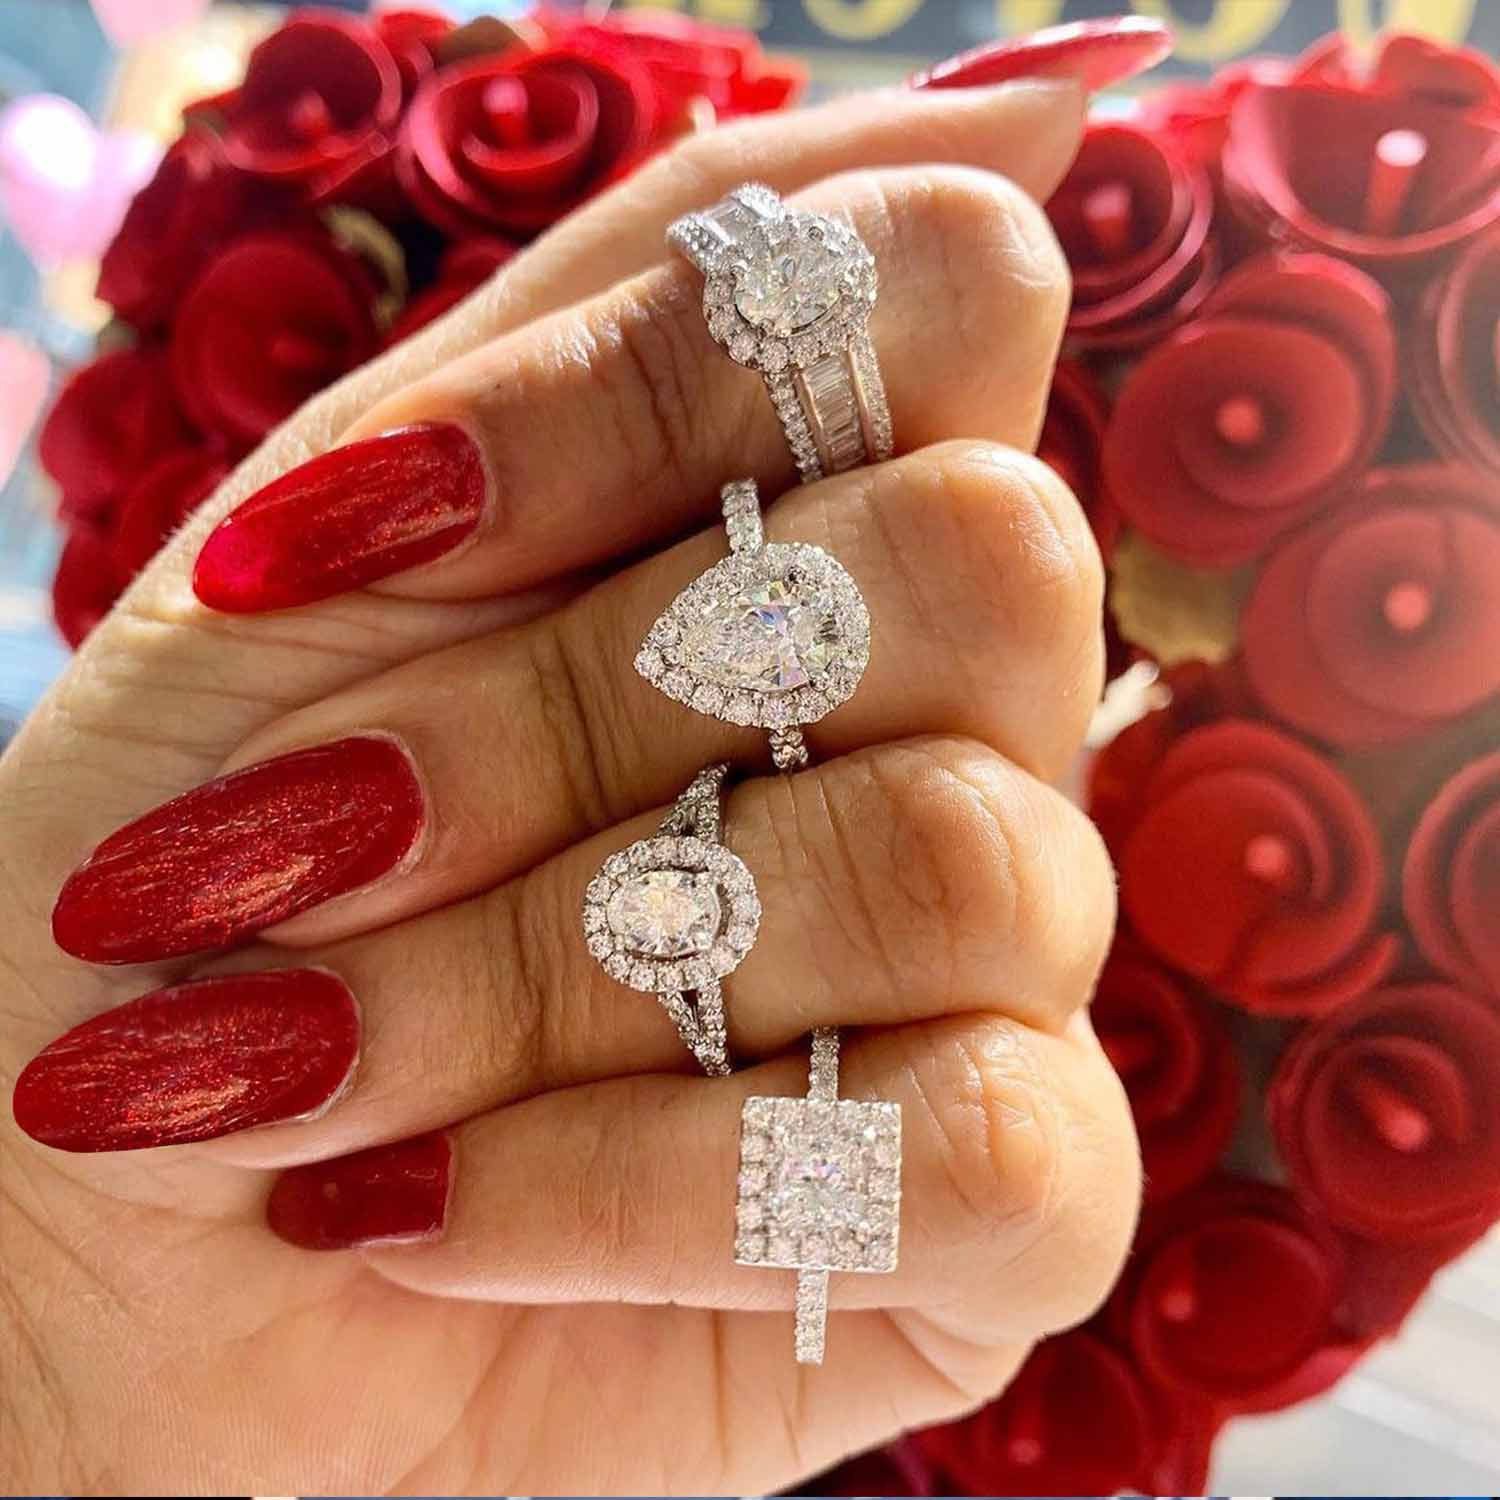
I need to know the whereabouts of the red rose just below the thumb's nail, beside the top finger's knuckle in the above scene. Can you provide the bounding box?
[1047,125,1215,350]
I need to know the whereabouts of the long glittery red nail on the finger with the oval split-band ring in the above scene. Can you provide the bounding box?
[14,969,360,1151]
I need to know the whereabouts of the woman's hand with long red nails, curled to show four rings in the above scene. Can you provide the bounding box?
[0,84,1139,1494]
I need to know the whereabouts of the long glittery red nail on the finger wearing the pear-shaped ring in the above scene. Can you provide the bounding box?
[53,738,426,963]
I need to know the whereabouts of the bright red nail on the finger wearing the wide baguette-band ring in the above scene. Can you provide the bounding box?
[192,422,486,615]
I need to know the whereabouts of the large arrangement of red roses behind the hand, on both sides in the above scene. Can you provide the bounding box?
[41,8,1500,1494]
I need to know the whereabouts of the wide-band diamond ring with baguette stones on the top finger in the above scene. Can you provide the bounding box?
[666,183,891,483]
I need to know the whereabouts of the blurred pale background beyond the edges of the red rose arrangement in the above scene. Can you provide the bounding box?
[0,0,1500,1494]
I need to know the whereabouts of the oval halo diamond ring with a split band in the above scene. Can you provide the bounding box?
[584,765,761,1077]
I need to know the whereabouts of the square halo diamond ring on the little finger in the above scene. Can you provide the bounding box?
[735,1026,902,1365]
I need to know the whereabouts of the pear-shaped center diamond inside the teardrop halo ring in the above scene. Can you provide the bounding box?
[683,578,843,693]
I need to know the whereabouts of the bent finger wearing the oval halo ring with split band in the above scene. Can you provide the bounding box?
[120,740,1115,1166]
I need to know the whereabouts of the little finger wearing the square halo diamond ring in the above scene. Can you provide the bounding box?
[316,1016,1140,1341]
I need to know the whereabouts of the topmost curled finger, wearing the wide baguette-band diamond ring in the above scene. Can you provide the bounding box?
[194,167,1068,614]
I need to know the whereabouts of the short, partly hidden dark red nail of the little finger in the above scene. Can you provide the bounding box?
[266,1133,453,1250]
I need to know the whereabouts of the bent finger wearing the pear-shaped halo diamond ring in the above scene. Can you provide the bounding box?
[53,444,1103,963]
